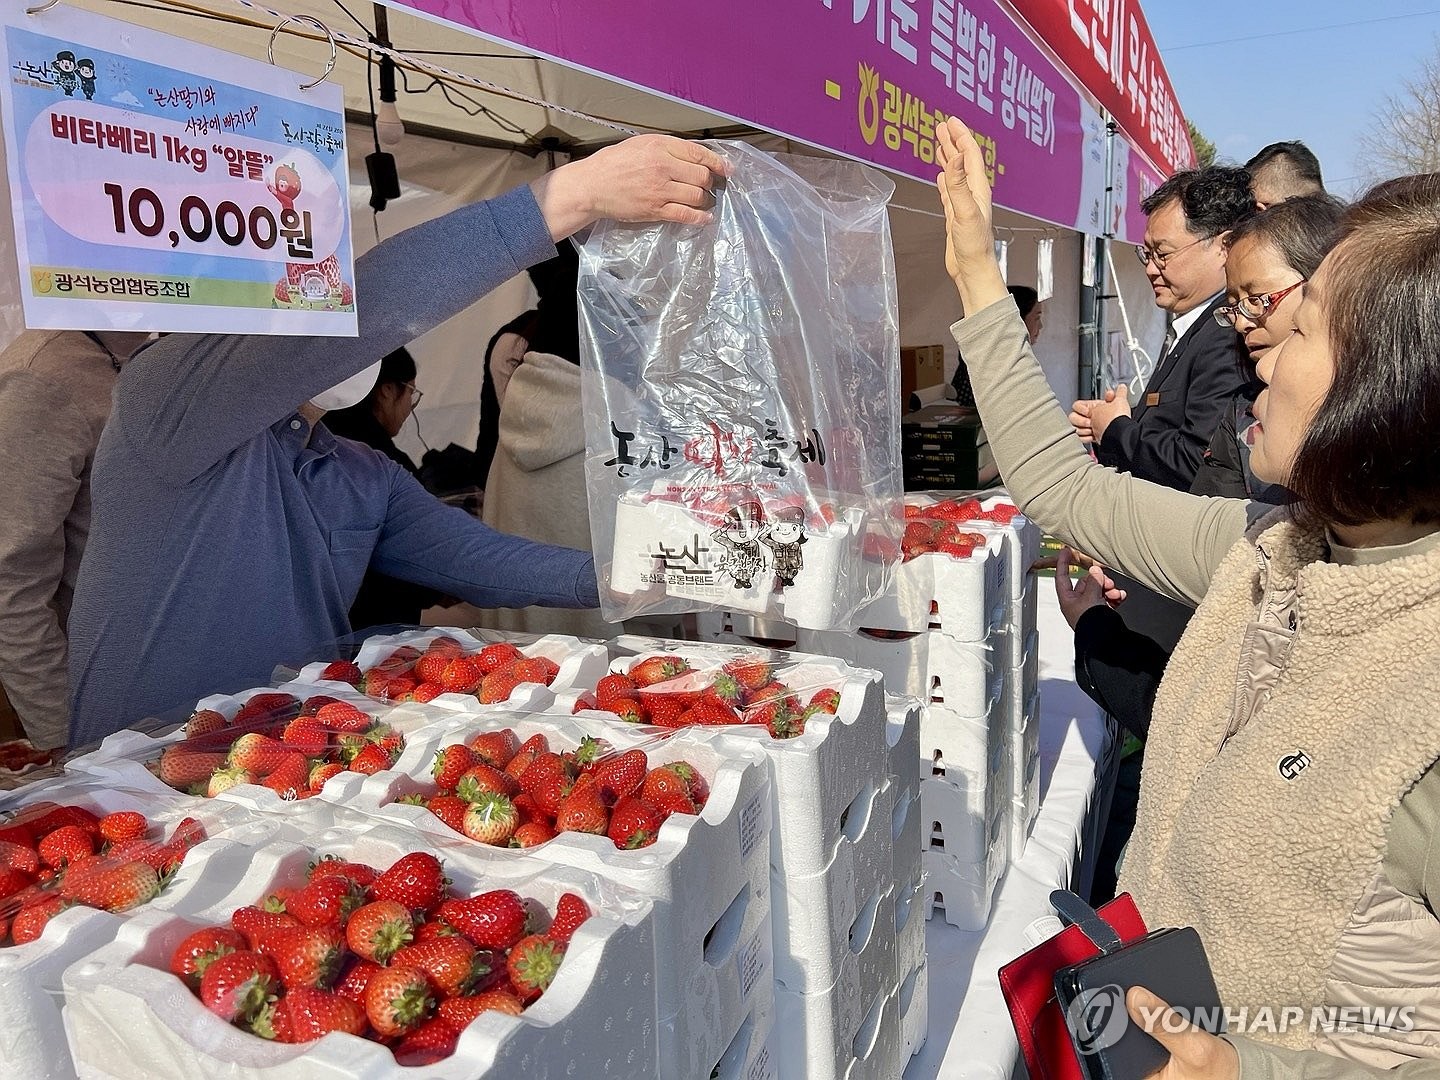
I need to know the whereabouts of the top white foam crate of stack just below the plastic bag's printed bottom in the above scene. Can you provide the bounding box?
[599,636,888,876]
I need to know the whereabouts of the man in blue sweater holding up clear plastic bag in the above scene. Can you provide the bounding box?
[71,135,727,746]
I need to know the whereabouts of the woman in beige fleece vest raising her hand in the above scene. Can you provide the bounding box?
[939,112,1440,1080]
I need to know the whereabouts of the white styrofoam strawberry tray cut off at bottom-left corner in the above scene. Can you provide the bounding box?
[0,776,281,1080]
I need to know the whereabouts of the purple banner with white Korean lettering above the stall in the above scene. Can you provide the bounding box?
[393,0,1104,232]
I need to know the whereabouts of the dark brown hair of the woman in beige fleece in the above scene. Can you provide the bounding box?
[1287,173,1440,526]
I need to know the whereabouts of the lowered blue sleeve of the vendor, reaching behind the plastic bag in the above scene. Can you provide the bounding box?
[370,465,600,608]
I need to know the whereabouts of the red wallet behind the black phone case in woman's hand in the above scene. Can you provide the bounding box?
[999,893,1146,1080]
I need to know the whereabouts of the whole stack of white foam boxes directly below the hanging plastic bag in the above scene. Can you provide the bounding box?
[596,638,898,1080]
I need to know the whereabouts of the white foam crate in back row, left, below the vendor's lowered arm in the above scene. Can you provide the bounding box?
[297,626,608,713]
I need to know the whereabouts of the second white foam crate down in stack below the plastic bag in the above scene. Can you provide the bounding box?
[770,783,896,999]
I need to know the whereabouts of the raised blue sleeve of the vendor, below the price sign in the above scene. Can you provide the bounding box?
[112,184,554,482]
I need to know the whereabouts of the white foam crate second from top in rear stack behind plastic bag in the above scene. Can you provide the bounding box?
[799,629,1004,716]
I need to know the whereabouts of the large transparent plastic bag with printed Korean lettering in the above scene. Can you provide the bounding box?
[576,143,903,629]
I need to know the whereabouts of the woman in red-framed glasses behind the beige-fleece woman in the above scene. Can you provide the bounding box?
[1189,194,1345,504]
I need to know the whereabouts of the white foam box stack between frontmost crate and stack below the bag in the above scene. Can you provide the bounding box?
[335,710,773,1080]
